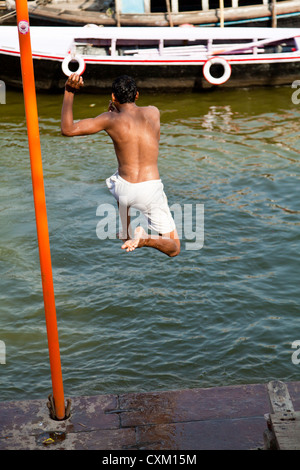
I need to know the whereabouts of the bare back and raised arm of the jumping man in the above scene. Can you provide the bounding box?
[62,74,160,183]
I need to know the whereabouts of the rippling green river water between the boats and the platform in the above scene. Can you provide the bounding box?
[0,87,300,401]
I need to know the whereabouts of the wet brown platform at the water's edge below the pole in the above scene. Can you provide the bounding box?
[0,382,300,451]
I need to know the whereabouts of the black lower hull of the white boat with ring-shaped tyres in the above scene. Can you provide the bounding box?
[0,55,300,93]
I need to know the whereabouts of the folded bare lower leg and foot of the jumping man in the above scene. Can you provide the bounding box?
[122,227,180,257]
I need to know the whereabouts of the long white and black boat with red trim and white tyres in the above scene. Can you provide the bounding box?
[0,25,300,93]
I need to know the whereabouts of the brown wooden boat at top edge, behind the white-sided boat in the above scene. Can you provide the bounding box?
[22,0,300,27]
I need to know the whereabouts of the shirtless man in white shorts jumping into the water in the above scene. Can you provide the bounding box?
[61,74,180,257]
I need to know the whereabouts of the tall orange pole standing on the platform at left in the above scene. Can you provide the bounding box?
[16,0,65,419]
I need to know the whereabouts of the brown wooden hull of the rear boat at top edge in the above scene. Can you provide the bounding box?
[29,0,300,27]
